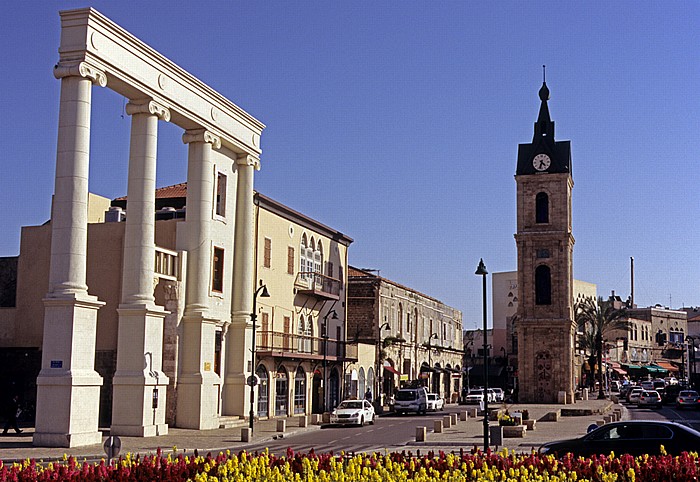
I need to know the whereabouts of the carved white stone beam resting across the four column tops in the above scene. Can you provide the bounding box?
[55,8,265,155]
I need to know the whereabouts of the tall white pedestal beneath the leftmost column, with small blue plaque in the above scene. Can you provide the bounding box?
[32,294,104,447]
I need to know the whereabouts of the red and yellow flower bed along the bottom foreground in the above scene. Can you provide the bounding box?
[0,450,700,482]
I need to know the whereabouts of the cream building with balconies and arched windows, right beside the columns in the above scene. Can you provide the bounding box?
[250,193,358,417]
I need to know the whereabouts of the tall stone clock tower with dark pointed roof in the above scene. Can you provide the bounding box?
[515,82,576,403]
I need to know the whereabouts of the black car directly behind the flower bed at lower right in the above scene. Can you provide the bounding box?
[539,420,700,457]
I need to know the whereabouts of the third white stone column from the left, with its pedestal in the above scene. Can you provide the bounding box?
[175,129,221,430]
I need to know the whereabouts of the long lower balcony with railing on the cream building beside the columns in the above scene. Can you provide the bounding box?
[255,331,357,361]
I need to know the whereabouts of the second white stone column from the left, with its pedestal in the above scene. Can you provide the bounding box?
[111,100,170,437]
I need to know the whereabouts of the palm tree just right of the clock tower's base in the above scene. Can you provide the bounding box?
[574,297,629,399]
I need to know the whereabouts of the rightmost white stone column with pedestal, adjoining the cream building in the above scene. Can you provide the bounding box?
[224,154,260,415]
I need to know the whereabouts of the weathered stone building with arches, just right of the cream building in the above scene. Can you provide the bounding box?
[348,267,463,402]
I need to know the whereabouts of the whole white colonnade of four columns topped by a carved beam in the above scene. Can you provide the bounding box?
[33,8,264,447]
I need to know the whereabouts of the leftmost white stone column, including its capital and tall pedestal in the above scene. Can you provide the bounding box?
[33,62,107,447]
